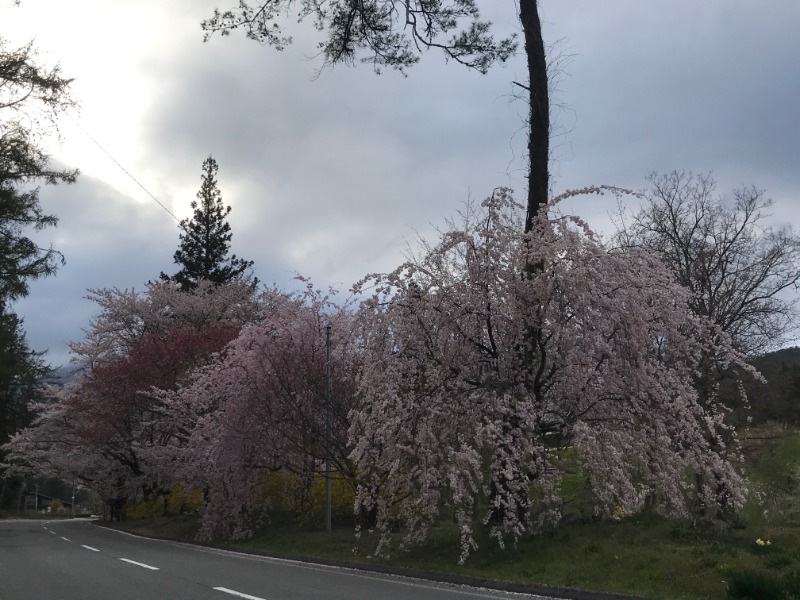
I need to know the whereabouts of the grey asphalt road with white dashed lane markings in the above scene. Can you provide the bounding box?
[0,520,564,600]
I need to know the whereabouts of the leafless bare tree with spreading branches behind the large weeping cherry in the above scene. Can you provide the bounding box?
[617,171,800,355]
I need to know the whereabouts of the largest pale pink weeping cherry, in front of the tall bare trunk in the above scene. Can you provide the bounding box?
[351,188,747,560]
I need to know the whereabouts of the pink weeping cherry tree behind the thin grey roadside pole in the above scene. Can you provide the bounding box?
[163,284,359,539]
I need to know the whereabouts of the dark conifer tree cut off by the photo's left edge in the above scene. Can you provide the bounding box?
[0,31,77,488]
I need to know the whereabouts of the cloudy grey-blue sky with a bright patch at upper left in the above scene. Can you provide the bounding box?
[0,0,800,366]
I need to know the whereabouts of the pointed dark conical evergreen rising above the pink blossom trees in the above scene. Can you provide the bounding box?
[166,156,253,290]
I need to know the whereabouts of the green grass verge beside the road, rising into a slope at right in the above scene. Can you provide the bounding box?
[103,422,800,600]
